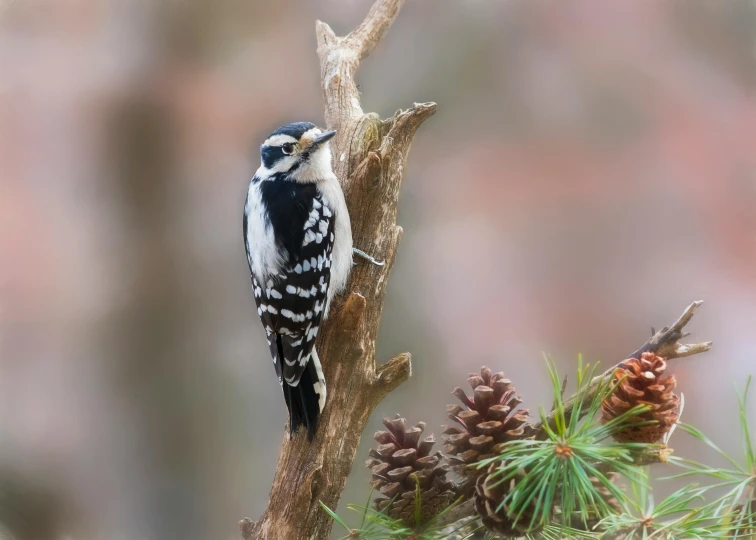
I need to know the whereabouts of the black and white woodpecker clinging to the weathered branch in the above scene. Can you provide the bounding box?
[244,122,352,439]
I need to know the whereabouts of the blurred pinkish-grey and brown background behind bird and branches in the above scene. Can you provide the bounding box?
[0,0,756,540]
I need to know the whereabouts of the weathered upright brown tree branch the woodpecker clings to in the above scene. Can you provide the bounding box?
[240,0,436,540]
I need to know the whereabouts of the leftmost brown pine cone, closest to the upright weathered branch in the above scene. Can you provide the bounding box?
[365,415,454,527]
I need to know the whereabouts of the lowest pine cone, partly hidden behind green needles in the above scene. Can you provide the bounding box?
[475,462,542,537]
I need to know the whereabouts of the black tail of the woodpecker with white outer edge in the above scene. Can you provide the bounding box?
[280,348,326,440]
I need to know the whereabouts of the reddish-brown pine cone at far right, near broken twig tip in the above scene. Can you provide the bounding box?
[602,352,680,443]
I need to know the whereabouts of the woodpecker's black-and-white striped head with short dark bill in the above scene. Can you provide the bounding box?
[255,122,336,182]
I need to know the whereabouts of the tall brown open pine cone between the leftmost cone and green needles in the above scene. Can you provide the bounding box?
[442,367,533,480]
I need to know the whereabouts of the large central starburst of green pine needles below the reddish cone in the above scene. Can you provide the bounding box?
[479,357,656,530]
